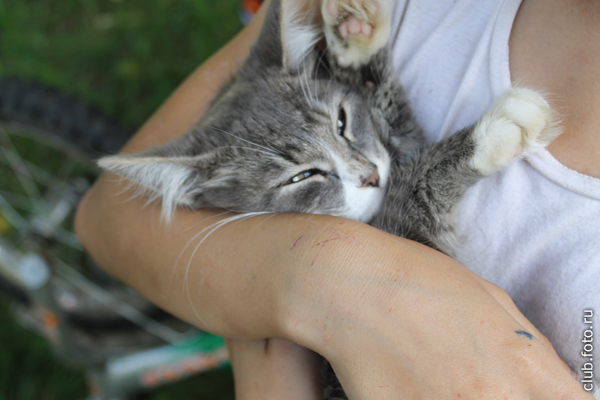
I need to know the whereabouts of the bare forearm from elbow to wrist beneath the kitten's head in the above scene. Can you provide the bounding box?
[78,177,372,339]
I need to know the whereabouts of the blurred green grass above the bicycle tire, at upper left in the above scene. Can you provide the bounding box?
[0,0,241,128]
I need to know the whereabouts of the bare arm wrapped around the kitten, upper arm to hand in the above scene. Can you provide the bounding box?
[72,0,588,398]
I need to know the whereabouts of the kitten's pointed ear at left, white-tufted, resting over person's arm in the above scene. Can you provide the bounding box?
[98,144,226,221]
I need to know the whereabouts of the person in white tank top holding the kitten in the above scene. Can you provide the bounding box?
[76,0,600,399]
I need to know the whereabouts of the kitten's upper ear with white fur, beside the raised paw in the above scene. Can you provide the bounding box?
[246,0,323,73]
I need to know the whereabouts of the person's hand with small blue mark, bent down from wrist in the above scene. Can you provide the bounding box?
[278,225,592,400]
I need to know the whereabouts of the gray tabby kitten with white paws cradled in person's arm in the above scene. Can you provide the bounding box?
[99,0,559,399]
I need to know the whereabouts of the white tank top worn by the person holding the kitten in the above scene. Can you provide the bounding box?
[392,0,600,386]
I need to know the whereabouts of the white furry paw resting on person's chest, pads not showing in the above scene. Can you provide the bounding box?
[471,88,561,175]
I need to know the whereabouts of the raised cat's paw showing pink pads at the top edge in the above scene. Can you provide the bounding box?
[321,0,391,67]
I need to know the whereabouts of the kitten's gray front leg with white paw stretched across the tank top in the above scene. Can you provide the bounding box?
[373,89,560,255]
